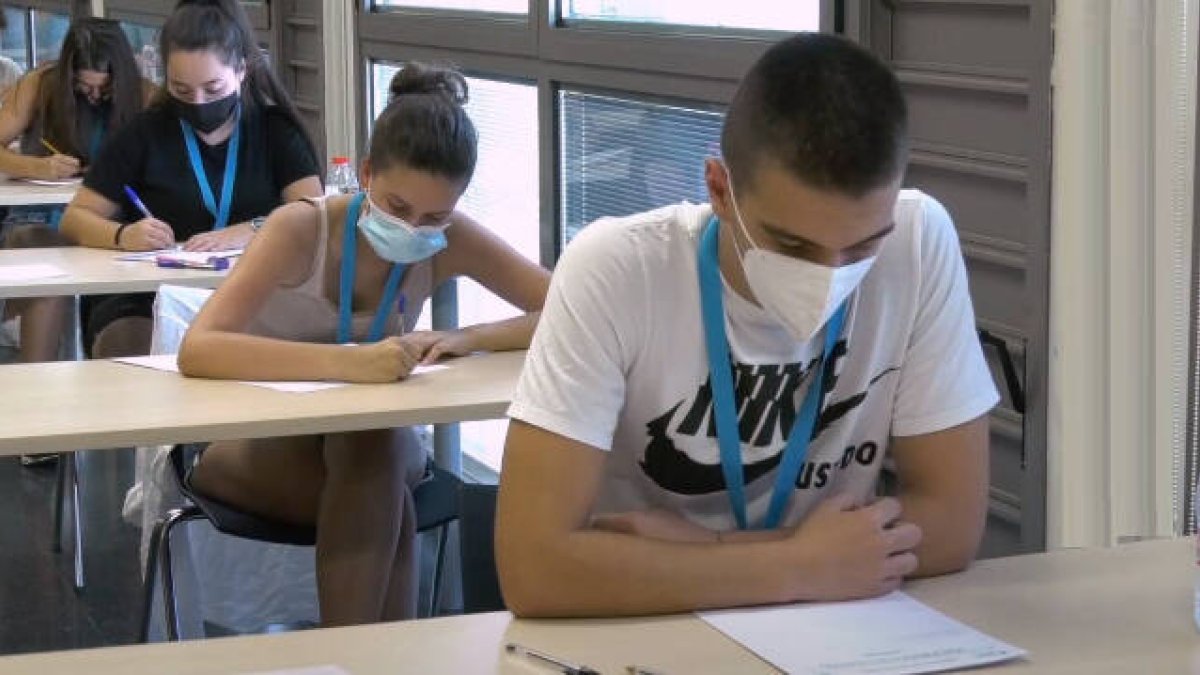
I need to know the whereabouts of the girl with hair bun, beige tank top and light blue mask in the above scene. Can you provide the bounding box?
[179,64,550,626]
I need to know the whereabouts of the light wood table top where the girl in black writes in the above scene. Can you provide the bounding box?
[0,246,226,299]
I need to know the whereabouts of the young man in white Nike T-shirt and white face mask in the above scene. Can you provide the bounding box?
[497,34,997,616]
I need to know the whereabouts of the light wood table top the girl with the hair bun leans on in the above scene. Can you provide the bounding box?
[0,352,524,455]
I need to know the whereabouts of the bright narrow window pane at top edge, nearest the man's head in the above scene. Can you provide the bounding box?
[563,0,821,32]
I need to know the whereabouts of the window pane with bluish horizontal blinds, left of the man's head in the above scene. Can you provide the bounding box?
[558,90,722,244]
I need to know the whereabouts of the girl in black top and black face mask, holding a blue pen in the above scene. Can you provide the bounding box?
[62,0,322,357]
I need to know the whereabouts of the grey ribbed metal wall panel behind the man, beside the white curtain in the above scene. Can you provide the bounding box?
[866,0,1052,555]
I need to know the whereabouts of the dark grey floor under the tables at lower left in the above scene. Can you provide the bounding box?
[0,450,142,653]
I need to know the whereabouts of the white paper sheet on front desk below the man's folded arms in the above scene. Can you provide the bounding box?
[697,591,1025,675]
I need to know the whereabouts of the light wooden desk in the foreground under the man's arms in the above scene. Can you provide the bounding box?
[0,539,1200,675]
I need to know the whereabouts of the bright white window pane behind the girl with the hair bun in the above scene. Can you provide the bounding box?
[371,64,541,471]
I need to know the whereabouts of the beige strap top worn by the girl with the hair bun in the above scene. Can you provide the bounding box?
[247,198,433,342]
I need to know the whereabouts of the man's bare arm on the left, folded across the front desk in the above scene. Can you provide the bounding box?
[496,420,919,616]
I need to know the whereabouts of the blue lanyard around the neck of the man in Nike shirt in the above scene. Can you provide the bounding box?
[700,216,846,530]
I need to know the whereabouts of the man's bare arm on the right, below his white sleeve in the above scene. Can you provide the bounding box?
[890,416,988,577]
